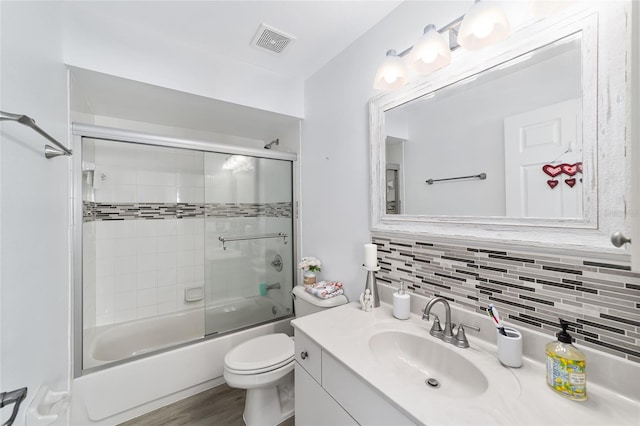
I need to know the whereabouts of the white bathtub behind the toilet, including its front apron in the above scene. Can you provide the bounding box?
[70,297,293,425]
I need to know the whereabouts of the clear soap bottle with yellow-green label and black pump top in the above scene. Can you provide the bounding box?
[546,318,587,401]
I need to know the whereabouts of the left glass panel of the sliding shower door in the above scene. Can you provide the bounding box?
[78,138,204,370]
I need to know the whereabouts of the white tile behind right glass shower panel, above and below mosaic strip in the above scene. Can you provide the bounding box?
[205,154,292,305]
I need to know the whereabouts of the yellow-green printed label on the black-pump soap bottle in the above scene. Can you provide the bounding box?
[547,352,587,399]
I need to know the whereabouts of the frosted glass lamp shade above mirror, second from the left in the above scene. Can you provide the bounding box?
[408,24,451,74]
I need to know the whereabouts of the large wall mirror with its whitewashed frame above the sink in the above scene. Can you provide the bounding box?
[370,13,628,249]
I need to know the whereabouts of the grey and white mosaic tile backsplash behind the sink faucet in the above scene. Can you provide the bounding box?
[373,234,640,363]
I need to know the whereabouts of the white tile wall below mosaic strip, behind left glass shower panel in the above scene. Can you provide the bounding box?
[94,218,204,327]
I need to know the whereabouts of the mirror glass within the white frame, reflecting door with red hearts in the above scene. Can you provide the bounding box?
[385,32,593,220]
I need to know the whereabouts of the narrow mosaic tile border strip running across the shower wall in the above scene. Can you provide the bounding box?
[82,201,292,222]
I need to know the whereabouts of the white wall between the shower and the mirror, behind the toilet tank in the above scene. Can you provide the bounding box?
[301,1,469,300]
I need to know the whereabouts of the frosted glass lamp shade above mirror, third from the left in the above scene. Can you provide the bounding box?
[458,0,511,50]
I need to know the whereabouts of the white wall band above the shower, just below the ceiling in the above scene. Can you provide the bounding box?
[64,2,304,117]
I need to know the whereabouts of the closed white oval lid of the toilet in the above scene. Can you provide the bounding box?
[224,333,295,374]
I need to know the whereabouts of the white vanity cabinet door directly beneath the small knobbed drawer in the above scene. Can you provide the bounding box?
[295,362,358,426]
